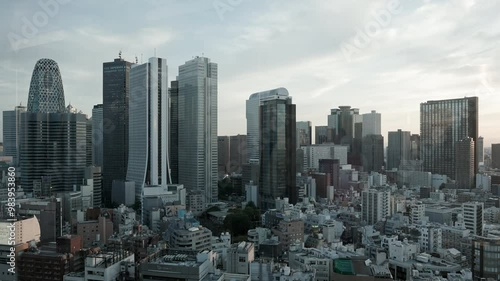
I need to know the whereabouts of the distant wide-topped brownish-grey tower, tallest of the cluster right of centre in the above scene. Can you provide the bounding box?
[328,106,362,144]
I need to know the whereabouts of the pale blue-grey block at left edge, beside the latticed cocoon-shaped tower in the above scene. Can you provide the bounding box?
[3,105,26,165]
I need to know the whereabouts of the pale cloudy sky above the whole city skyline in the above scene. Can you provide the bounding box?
[0,0,500,147]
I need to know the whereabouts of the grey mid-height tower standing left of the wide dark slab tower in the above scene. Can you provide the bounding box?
[386,129,411,170]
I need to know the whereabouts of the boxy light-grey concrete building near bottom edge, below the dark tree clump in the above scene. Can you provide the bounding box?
[226,242,255,274]
